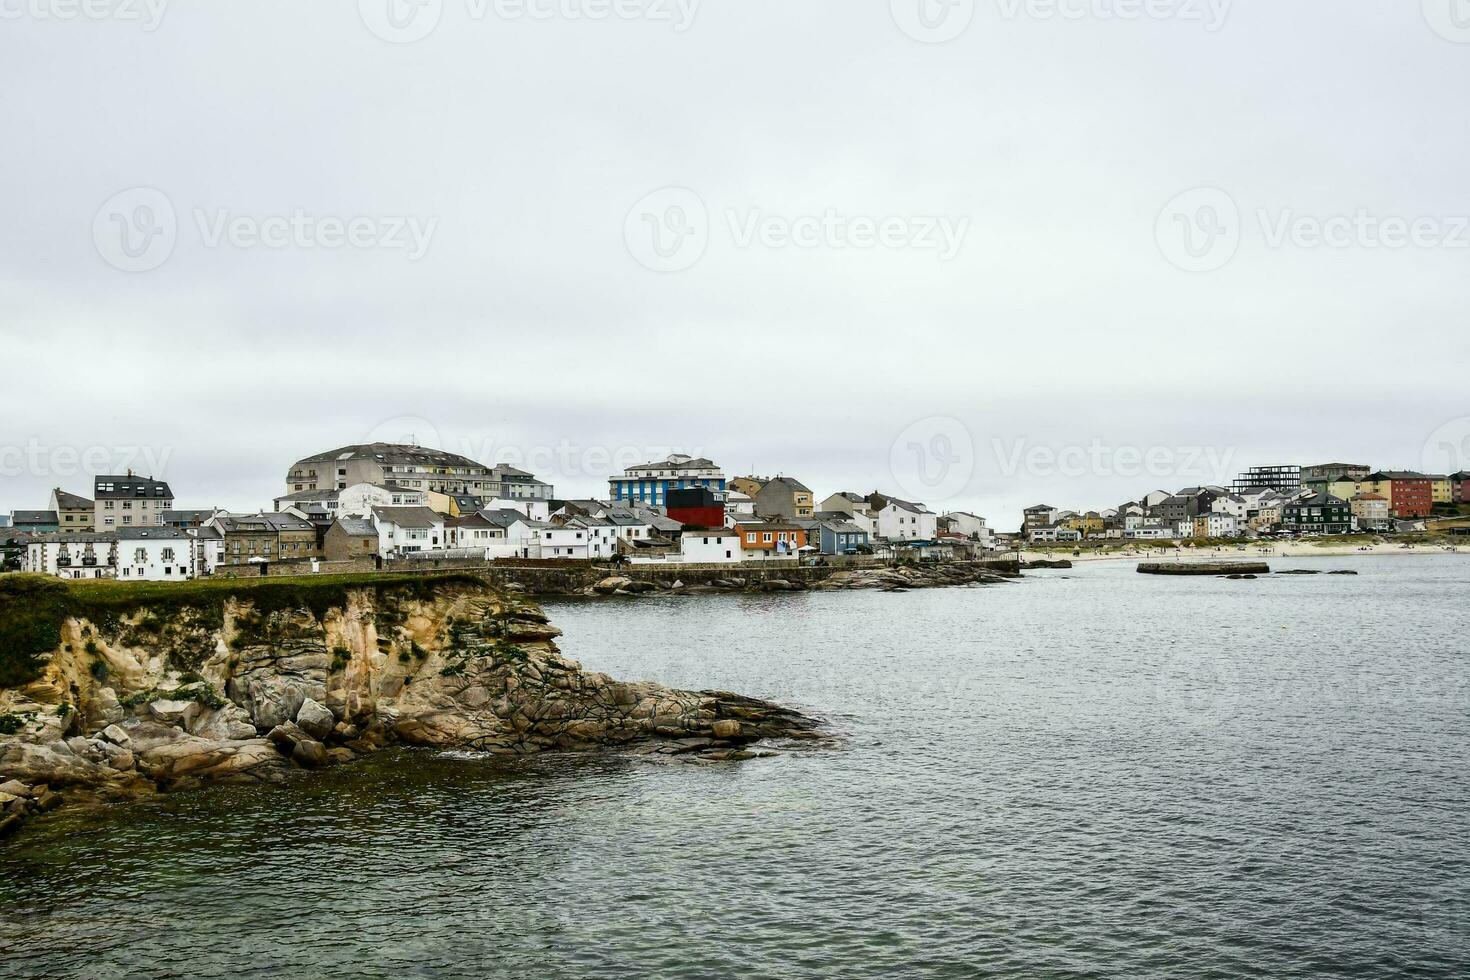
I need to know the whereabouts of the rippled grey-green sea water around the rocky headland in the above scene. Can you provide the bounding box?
[0,555,1470,980]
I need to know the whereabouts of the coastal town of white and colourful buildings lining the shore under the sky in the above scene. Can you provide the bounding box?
[0,442,1470,582]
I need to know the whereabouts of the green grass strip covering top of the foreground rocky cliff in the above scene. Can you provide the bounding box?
[0,572,485,688]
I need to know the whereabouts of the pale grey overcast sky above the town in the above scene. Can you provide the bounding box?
[0,0,1470,527]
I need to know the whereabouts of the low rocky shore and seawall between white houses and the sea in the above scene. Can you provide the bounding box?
[581,561,1019,595]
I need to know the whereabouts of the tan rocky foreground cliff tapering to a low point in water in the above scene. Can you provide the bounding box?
[0,576,816,835]
